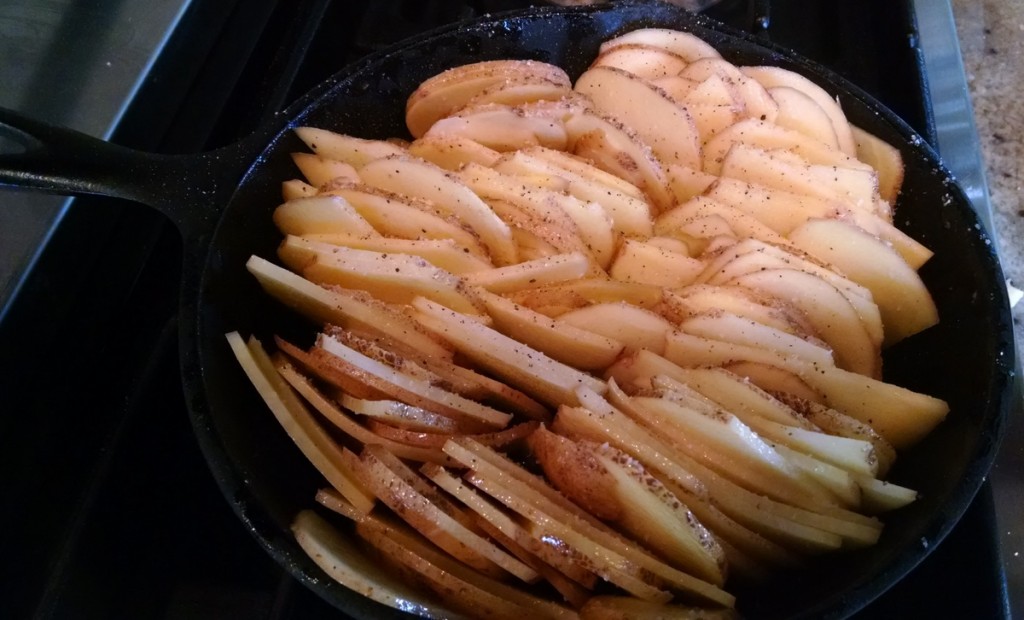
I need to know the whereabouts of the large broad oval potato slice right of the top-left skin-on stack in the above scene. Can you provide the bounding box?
[573,67,700,167]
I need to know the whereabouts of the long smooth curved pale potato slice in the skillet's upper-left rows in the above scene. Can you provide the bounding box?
[359,158,516,265]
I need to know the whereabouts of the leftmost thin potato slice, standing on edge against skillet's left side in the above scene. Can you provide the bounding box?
[226,332,374,513]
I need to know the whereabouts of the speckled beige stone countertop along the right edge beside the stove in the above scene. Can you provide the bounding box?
[952,0,1024,618]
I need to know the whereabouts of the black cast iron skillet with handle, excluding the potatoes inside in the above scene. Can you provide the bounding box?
[0,2,1014,618]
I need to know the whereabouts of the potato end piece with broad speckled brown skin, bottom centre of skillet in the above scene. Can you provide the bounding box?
[529,428,725,586]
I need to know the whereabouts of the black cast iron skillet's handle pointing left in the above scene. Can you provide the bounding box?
[0,108,245,232]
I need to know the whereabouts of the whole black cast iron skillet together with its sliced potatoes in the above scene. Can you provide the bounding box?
[4,3,1014,617]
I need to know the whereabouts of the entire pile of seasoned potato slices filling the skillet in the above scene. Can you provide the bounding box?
[228,24,962,618]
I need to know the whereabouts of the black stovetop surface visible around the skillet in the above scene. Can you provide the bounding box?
[0,0,1008,619]
